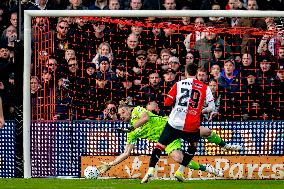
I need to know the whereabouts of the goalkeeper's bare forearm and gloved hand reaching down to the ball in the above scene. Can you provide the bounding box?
[98,144,135,173]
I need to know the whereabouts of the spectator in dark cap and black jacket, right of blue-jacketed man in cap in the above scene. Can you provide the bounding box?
[241,71,269,120]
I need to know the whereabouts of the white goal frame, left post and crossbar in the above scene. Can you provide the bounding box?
[23,10,284,178]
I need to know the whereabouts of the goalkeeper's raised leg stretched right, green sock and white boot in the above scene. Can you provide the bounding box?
[200,127,242,151]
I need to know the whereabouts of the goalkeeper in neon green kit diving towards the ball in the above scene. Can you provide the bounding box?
[98,105,242,181]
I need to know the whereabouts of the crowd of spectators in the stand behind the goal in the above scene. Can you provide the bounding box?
[0,0,284,121]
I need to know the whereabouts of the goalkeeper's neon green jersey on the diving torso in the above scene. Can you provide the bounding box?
[126,106,168,144]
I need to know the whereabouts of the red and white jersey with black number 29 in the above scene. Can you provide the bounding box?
[165,78,214,132]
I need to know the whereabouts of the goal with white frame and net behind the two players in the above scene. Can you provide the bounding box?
[17,11,284,179]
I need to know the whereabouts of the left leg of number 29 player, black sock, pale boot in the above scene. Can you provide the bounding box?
[141,123,178,183]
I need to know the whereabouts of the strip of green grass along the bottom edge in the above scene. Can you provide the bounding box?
[0,178,284,189]
